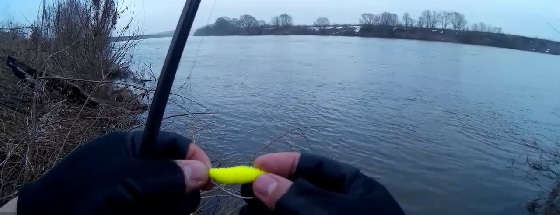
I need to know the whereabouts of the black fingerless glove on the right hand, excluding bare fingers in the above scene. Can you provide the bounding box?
[240,154,404,215]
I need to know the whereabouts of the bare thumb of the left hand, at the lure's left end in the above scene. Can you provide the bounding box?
[175,160,208,193]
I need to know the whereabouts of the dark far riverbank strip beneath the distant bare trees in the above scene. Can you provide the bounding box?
[194,25,560,55]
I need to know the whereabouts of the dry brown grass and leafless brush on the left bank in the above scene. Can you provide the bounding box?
[0,0,152,204]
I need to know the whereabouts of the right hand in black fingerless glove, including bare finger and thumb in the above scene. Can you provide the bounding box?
[240,153,404,215]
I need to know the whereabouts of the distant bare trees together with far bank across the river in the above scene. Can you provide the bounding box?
[195,10,560,55]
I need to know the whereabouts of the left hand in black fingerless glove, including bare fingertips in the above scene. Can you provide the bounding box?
[17,132,210,214]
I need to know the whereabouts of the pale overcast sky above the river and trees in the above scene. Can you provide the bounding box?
[0,0,560,41]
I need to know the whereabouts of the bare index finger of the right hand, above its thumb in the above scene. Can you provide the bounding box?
[255,152,301,178]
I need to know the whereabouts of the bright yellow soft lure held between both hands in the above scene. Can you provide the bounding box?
[208,166,266,184]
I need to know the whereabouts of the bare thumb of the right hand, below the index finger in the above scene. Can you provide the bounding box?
[253,174,293,209]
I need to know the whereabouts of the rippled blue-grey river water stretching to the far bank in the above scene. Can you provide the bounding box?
[135,36,560,214]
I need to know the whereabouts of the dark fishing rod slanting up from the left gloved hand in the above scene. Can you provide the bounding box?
[140,0,201,154]
